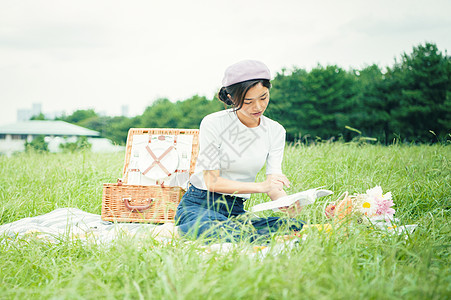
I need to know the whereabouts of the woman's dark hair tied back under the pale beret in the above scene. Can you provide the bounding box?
[218,79,271,111]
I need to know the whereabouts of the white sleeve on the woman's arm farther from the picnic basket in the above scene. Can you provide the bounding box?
[266,123,286,175]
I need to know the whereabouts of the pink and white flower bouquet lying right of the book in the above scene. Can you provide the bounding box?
[325,186,395,222]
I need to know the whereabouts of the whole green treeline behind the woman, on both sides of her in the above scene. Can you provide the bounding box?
[55,43,451,144]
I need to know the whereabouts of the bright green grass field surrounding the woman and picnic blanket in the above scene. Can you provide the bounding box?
[0,143,451,299]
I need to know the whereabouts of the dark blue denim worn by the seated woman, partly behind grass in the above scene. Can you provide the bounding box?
[175,185,303,242]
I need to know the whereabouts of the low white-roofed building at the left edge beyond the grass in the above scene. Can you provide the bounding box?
[0,120,124,156]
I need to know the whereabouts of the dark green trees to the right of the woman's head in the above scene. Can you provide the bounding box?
[268,43,451,143]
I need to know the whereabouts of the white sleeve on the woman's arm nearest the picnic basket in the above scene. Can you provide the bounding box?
[196,117,221,170]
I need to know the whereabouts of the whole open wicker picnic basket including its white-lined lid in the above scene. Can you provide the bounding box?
[101,128,199,223]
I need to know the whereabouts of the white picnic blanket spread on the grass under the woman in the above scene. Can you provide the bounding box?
[0,208,416,258]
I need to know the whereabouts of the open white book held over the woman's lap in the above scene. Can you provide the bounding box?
[249,188,333,212]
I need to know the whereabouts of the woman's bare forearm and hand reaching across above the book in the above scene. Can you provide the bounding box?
[204,170,290,195]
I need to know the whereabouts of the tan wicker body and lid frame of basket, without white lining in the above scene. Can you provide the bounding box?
[101,128,199,223]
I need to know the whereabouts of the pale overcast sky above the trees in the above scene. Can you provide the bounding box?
[0,0,451,125]
